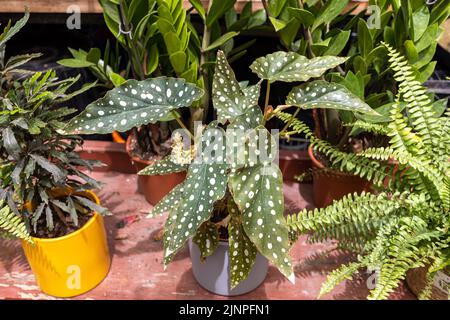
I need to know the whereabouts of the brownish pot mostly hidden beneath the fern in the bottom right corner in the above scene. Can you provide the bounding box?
[406,267,450,300]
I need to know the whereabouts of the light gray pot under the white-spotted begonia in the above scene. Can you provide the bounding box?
[189,239,269,296]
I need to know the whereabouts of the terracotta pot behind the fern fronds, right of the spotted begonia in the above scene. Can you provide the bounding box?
[308,146,371,208]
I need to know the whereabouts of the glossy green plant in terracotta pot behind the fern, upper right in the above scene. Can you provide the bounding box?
[263,0,449,207]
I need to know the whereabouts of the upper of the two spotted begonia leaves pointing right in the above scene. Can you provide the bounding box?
[250,51,347,82]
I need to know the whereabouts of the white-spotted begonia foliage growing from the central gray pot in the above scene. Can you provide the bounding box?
[66,38,374,288]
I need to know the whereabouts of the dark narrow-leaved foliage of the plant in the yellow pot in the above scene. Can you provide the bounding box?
[0,12,106,240]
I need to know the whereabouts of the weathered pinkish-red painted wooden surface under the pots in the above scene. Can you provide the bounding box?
[0,172,414,299]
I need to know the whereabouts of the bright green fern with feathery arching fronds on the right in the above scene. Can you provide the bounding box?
[278,44,450,299]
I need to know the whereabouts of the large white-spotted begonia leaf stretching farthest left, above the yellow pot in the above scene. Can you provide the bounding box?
[65,77,203,134]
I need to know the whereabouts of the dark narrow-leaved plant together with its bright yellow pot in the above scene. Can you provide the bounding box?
[0,12,110,297]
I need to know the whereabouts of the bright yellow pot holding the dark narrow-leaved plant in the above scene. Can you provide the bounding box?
[22,191,111,297]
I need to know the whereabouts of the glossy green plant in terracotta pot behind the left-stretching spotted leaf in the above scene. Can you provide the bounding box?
[60,0,265,205]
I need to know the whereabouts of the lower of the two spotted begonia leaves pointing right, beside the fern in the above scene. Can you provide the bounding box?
[286,80,378,115]
